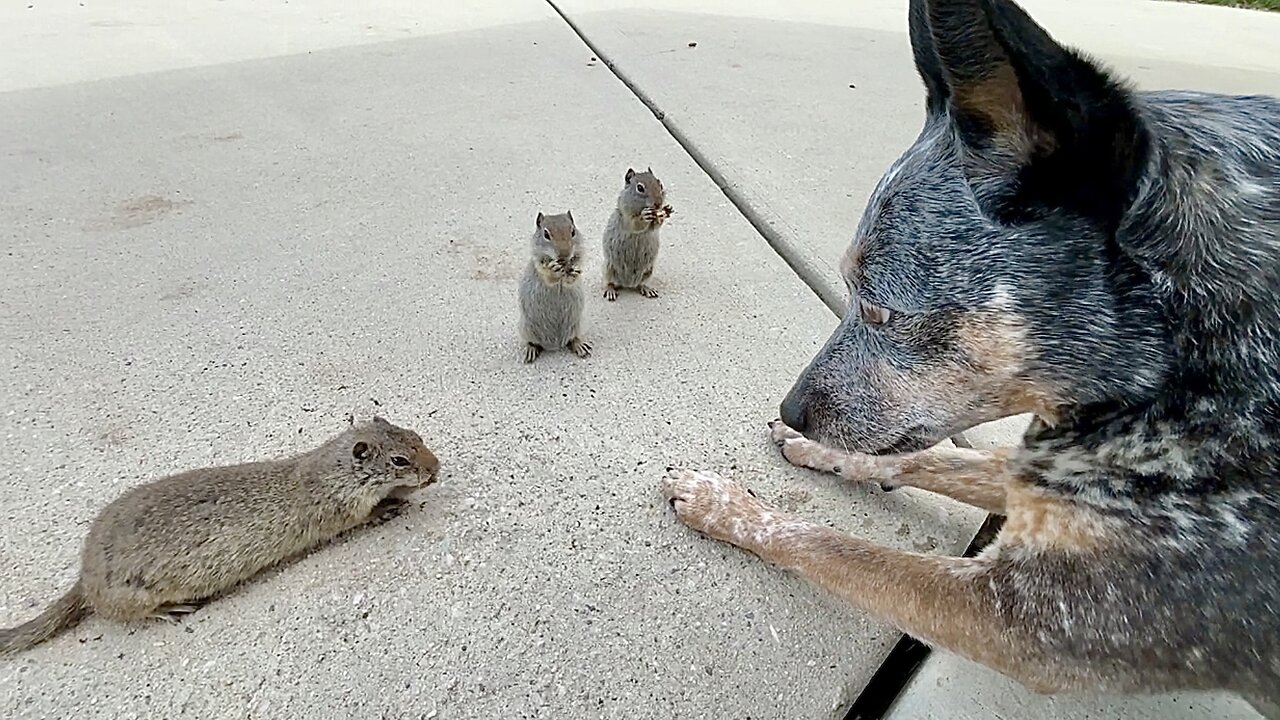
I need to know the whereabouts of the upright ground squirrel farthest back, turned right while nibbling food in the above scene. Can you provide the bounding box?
[604,168,675,301]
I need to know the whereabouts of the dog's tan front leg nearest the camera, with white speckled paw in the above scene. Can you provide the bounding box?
[663,469,1065,692]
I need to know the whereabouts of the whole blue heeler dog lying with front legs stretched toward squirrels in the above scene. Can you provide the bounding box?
[663,0,1280,717]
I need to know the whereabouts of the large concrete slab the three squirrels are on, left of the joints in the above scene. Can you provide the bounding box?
[0,0,977,719]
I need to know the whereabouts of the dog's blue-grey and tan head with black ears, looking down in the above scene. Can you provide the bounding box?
[782,0,1169,452]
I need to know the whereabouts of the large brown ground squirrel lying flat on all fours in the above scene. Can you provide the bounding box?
[0,418,440,655]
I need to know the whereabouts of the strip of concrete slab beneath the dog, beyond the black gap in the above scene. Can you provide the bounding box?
[886,653,1262,720]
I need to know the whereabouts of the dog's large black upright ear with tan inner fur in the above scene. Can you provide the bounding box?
[911,0,1147,229]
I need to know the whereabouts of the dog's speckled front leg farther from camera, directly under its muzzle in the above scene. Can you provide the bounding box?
[769,420,1014,515]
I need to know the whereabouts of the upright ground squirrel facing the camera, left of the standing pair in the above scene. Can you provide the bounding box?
[520,213,591,363]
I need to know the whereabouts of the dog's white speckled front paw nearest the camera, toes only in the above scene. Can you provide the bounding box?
[662,468,774,544]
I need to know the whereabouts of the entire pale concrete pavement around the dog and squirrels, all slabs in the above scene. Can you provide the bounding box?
[0,0,1280,720]
